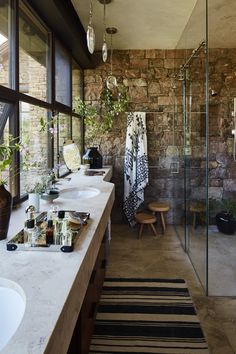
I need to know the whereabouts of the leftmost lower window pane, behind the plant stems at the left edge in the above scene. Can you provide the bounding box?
[0,102,17,196]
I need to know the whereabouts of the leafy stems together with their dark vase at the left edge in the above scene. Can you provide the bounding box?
[0,137,20,240]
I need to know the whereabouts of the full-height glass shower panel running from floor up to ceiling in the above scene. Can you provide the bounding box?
[176,0,208,291]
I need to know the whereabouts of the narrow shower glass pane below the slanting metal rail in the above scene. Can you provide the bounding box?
[184,51,207,288]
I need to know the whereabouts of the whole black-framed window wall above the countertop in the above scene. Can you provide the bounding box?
[0,0,83,203]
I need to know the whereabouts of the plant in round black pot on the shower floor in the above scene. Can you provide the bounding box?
[216,199,236,235]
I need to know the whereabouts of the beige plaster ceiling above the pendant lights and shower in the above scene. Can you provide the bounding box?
[71,0,236,50]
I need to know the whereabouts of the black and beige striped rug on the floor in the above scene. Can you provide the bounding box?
[89,278,209,354]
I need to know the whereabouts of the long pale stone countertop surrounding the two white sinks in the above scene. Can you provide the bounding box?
[0,167,115,354]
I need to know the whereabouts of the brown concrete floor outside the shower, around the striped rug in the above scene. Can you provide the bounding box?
[107,224,236,354]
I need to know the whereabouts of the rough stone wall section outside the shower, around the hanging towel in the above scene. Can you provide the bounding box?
[84,50,184,222]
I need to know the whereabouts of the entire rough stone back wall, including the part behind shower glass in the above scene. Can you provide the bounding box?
[84,49,236,223]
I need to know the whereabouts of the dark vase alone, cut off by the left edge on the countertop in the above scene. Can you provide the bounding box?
[0,184,12,240]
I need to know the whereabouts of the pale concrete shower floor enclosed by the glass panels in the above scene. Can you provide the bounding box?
[176,225,236,297]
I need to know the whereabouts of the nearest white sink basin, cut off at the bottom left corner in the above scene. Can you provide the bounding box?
[0,278,26,351]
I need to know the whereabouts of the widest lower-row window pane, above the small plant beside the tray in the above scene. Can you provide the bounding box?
[20,102,49,195]
